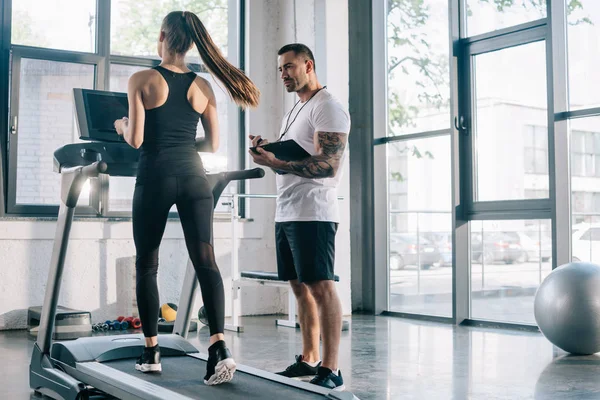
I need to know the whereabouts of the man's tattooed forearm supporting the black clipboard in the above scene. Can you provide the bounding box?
[276,132,348,179]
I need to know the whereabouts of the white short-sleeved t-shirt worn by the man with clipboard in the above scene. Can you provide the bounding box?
[275,89,350,223]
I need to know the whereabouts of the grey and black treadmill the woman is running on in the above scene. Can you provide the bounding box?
[29,89,357,400]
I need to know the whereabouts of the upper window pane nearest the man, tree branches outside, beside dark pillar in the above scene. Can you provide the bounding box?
[387,0,450,136]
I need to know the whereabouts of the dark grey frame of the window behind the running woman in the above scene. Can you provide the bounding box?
[0,0,247,218]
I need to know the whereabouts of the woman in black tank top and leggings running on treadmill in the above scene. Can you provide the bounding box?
[114,11,260,385]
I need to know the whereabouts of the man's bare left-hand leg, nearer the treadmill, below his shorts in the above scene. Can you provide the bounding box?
[290,279,321,363]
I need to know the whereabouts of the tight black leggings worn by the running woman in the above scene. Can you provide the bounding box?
[133,176,225,337]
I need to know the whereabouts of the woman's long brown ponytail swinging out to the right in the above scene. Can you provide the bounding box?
[183,11,260,108]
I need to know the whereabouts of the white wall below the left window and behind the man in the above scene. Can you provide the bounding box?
[0,0,351,329]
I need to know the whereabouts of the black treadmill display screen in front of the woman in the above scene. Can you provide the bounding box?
[73,88,129,143]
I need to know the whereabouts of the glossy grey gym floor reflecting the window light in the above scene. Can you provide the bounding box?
[0,315,600,400]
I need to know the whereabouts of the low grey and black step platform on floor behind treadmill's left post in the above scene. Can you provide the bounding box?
[27,306,92,340]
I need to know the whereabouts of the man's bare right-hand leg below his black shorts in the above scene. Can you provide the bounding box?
[307,280,342,372]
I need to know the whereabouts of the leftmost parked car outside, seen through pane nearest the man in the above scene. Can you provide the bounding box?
[390,233,441,270]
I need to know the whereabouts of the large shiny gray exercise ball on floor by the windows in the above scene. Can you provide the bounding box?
[534,262,600,354]
